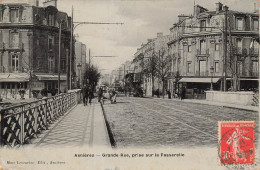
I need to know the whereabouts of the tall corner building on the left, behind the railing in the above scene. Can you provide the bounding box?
[0,3,73,98]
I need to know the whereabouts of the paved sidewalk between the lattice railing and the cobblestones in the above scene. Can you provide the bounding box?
[33,101,111,148]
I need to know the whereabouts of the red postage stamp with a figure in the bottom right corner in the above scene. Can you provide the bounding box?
[218,121,255,165]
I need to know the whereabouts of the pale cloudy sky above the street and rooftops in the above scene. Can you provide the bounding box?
[2,0,259,73]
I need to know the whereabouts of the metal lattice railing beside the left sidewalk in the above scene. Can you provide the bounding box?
[0,90,81,148]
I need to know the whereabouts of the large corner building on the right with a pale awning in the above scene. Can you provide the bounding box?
[168,3,259,99]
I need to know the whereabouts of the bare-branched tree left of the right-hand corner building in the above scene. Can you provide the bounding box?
[155,47,172,98]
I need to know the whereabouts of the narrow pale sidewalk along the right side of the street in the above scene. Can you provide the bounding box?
[147,96,259,112]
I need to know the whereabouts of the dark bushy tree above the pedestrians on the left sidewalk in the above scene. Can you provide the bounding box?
[83,64,101,91]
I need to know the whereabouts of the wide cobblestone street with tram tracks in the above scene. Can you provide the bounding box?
[104,97,258,148]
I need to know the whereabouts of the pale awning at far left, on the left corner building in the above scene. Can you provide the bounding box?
[0,73,29,82]
